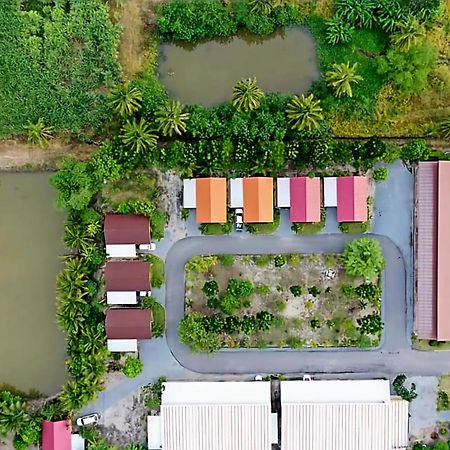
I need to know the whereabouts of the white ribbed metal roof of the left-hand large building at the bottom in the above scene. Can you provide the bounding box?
[161,381,271,450]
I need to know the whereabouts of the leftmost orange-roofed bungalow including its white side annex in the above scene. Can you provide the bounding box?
[183,178,227,223]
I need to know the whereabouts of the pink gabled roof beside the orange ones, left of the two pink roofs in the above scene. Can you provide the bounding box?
[290,177,320,222]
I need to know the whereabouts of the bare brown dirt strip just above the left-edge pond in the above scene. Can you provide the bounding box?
[0,139,97,171]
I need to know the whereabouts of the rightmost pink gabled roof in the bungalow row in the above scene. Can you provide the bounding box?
[337,177,368,222]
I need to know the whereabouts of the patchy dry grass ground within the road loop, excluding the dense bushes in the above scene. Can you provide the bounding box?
[185,254,381,348]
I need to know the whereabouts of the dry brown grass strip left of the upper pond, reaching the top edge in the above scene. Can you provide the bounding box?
[111,0,162,80]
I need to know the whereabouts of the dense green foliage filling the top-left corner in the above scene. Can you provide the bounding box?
[0,0,119,136]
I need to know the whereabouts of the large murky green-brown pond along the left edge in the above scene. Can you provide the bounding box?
[0,173,67,395]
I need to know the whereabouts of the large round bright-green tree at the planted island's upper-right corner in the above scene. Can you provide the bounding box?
[342,238,384,279]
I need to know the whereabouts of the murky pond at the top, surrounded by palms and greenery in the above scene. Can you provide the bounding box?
[158,27,320,106]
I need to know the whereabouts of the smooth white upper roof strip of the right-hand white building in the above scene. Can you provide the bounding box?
[281,380,391,404]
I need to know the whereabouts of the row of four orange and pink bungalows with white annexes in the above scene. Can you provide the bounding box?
[183,176,368,223]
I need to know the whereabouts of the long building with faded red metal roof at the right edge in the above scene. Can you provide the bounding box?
[414,161,450,341]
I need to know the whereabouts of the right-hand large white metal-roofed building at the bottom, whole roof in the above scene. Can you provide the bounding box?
[281,380,409,450]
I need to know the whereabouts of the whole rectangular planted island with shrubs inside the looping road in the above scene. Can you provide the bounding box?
[180,239,383,352]
